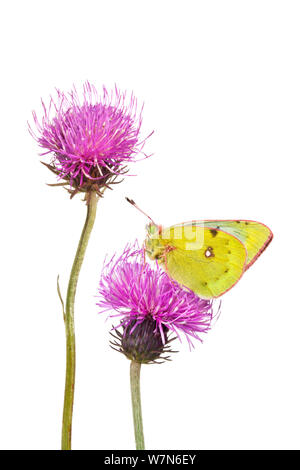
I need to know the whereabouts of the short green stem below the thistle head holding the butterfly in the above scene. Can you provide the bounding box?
[130,361,145,450]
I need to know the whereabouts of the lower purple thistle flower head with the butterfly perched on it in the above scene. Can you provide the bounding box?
[97,245,213,363]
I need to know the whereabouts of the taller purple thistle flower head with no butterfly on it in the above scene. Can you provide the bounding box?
[29,82,151,196]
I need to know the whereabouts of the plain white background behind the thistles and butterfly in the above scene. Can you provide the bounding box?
[0,0,300,449]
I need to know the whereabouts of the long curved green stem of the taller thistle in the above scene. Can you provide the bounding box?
[61,191,98,450]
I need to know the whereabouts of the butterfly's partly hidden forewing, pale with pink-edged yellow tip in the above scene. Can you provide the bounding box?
[196,220,273,269]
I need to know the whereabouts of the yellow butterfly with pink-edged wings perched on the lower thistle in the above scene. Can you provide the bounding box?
[127,199,273,299]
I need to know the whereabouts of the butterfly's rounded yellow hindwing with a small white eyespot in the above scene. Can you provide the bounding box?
[161,225,247,299]
